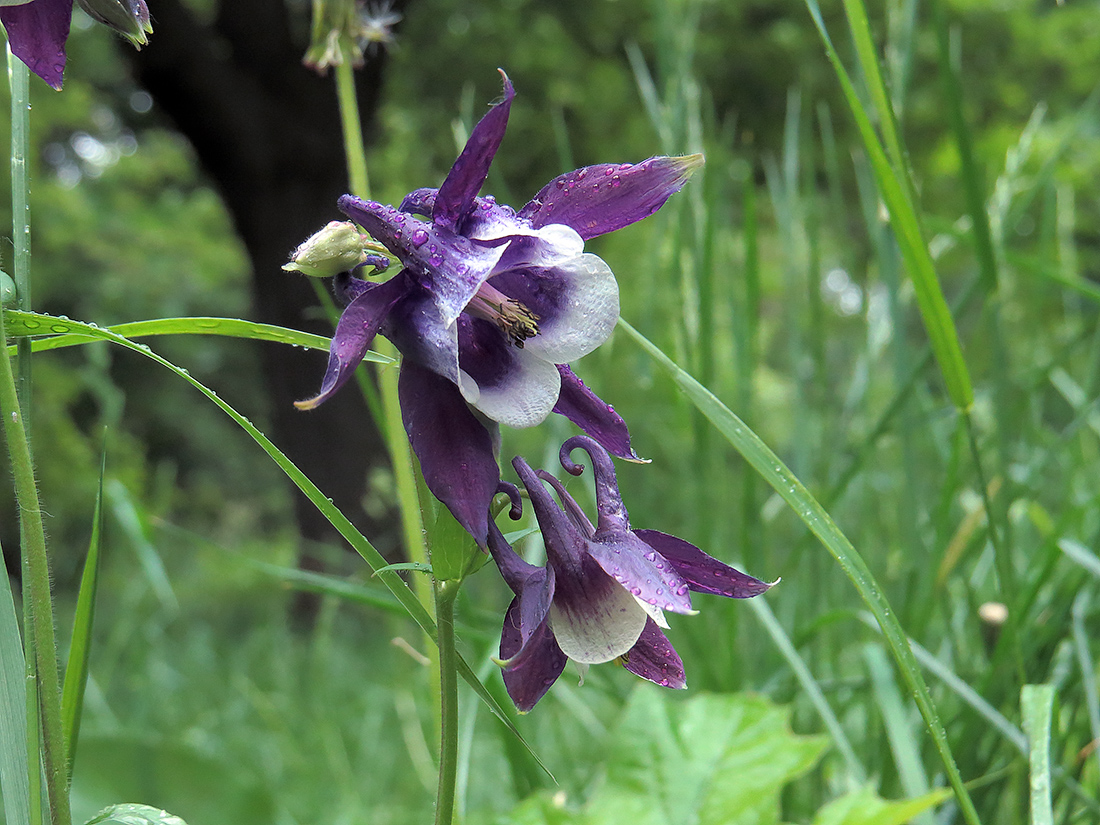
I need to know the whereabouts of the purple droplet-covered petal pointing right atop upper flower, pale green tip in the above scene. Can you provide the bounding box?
[519,155,703,240]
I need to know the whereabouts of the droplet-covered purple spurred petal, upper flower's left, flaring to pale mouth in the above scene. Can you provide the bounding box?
[338,195,504,326]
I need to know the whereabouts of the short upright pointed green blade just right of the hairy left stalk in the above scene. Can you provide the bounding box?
[62,442,107,782]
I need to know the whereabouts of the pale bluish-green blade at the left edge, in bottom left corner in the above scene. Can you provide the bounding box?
[0,530,32,823]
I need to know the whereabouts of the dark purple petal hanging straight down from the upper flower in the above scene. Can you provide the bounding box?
[397,361,501,547]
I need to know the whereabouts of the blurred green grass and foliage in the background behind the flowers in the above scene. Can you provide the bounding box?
[0,0,1100,825]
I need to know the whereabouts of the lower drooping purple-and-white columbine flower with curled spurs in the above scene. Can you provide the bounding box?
[488,436,772,712]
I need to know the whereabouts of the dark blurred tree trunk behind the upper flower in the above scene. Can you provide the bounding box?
[123,0,396,563]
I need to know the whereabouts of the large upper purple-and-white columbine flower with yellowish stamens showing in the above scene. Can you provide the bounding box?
[298,72,703,546]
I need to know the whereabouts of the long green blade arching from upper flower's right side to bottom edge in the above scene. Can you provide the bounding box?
[619,318,979,825]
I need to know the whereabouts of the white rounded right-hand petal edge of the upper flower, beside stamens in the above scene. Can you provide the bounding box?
[525,253,619,364]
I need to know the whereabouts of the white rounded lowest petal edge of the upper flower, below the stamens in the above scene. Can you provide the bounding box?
[459,349,561,428]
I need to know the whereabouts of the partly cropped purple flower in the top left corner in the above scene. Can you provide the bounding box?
[0,0,153,90]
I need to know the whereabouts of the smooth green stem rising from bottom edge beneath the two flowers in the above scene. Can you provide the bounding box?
[435,579,462,825]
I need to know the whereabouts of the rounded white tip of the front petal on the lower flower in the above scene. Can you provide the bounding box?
[550,587,648,664]
